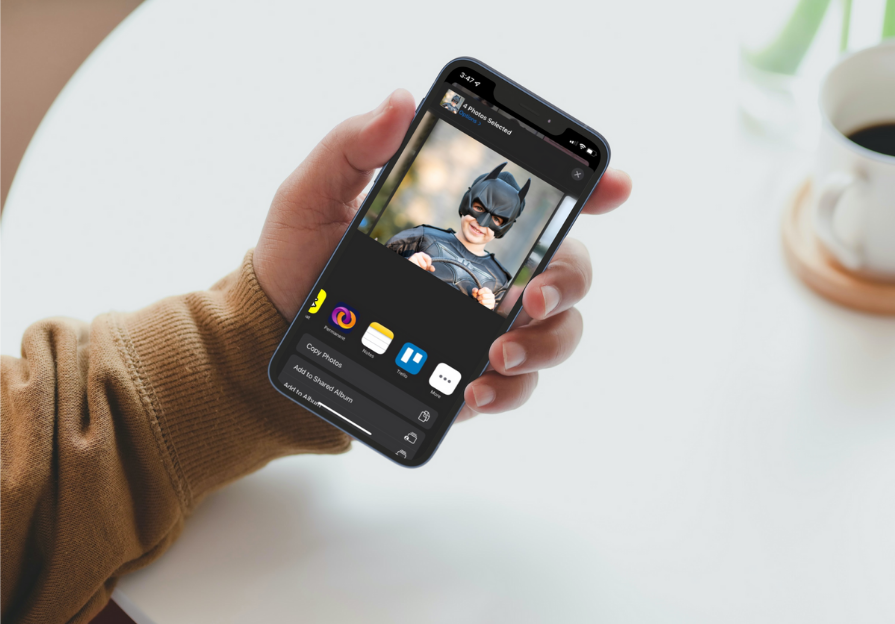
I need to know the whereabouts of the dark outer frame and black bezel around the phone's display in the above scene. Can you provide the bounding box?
[267,57,610,468]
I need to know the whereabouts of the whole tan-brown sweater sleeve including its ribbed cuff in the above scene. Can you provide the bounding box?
[0,252,349,624]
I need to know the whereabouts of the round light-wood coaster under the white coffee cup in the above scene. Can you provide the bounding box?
[783,179,895,315]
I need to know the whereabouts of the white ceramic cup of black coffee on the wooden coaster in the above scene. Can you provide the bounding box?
[814,41,895,281]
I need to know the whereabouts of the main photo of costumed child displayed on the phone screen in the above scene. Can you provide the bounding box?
[359,113,563,316]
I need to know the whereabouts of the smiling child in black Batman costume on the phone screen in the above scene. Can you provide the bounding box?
[385,163,531,310]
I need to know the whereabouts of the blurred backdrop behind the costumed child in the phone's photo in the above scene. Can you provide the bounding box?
[360,113,563,276]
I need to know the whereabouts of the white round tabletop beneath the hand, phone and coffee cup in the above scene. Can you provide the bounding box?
[2,0,895,624]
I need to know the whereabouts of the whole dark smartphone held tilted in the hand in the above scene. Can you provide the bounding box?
[268,58,609,467]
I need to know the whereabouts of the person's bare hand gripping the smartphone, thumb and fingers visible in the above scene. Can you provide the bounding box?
[254,90,631,420]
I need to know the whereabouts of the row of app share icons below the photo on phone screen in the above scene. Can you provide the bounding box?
[308,289,461,395]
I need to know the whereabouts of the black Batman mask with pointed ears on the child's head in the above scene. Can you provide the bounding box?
[460,163,531,238]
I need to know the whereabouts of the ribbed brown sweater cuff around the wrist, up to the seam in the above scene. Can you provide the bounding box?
[115,251,350,511]
